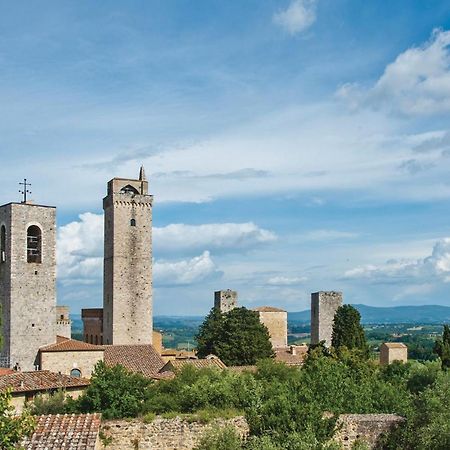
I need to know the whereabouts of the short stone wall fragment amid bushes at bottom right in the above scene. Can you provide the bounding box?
[334,414,405,449]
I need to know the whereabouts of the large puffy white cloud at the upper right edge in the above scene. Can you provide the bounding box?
[337,30,450,115]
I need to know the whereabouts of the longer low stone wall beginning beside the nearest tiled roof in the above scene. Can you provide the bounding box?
[101,417,249,450]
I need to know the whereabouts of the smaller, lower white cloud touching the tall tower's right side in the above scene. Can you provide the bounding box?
[153,251,221,286]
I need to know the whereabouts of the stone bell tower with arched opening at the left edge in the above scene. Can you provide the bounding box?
[0,202,56,370]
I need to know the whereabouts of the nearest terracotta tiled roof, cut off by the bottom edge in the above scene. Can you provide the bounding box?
[21,414,101,450]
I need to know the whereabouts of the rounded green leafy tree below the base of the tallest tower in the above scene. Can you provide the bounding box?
[76,361,152,419]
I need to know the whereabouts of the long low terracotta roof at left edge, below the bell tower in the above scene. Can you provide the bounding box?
[0,370,89,393]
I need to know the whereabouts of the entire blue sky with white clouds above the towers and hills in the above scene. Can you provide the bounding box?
[0,0,450,314]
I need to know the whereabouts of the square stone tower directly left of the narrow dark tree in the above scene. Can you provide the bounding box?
[311,291,342,347]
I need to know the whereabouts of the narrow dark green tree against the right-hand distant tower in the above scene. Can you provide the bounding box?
[332,305,369,356]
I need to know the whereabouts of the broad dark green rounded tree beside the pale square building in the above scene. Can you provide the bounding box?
[196,308,273,366]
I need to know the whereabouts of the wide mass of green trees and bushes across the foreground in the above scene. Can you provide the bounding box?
[26,346,450,450]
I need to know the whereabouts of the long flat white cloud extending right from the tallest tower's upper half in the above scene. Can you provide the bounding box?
[153,222,277,252]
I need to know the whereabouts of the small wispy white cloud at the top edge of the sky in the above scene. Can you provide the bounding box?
[273,0,317,35]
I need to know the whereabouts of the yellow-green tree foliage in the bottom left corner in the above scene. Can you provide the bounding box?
[0,391,36,450]
